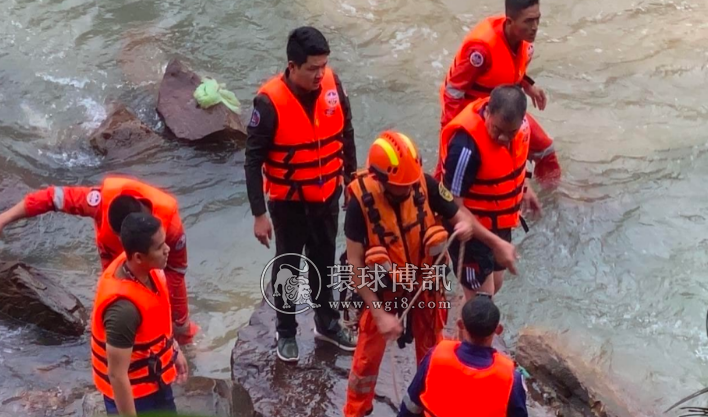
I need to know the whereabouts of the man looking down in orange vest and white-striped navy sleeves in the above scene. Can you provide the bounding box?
[440,85,541,299]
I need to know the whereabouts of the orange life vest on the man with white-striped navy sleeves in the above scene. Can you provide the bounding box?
[440,98,529,230]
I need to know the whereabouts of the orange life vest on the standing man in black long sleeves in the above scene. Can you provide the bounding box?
[258,68,344,202]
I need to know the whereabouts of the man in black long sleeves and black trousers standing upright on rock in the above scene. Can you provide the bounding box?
[244,27,357,362]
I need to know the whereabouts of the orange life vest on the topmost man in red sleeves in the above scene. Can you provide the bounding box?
[441,16,533,106]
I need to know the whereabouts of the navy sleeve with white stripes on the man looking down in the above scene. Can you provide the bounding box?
[443,129,481,197]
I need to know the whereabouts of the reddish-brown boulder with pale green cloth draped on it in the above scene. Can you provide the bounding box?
[157,59,246,143]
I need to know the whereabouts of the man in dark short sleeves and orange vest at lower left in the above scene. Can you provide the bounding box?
[91,213,188,416]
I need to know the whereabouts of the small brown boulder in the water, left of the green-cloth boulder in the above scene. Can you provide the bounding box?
[89,104,163,160]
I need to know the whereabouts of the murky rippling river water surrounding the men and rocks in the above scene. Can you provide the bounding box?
[0,0,708,410]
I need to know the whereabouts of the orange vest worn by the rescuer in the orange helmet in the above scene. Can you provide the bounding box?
[347,172,436,279]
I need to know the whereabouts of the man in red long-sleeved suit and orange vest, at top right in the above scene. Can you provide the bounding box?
[435,0,561,187]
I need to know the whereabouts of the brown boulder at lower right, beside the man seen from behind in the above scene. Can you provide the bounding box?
[516,328,646,417]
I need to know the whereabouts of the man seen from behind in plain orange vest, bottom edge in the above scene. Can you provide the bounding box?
[398,294,528,417]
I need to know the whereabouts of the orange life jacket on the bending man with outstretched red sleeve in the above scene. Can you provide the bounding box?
[96,177,179,267]
